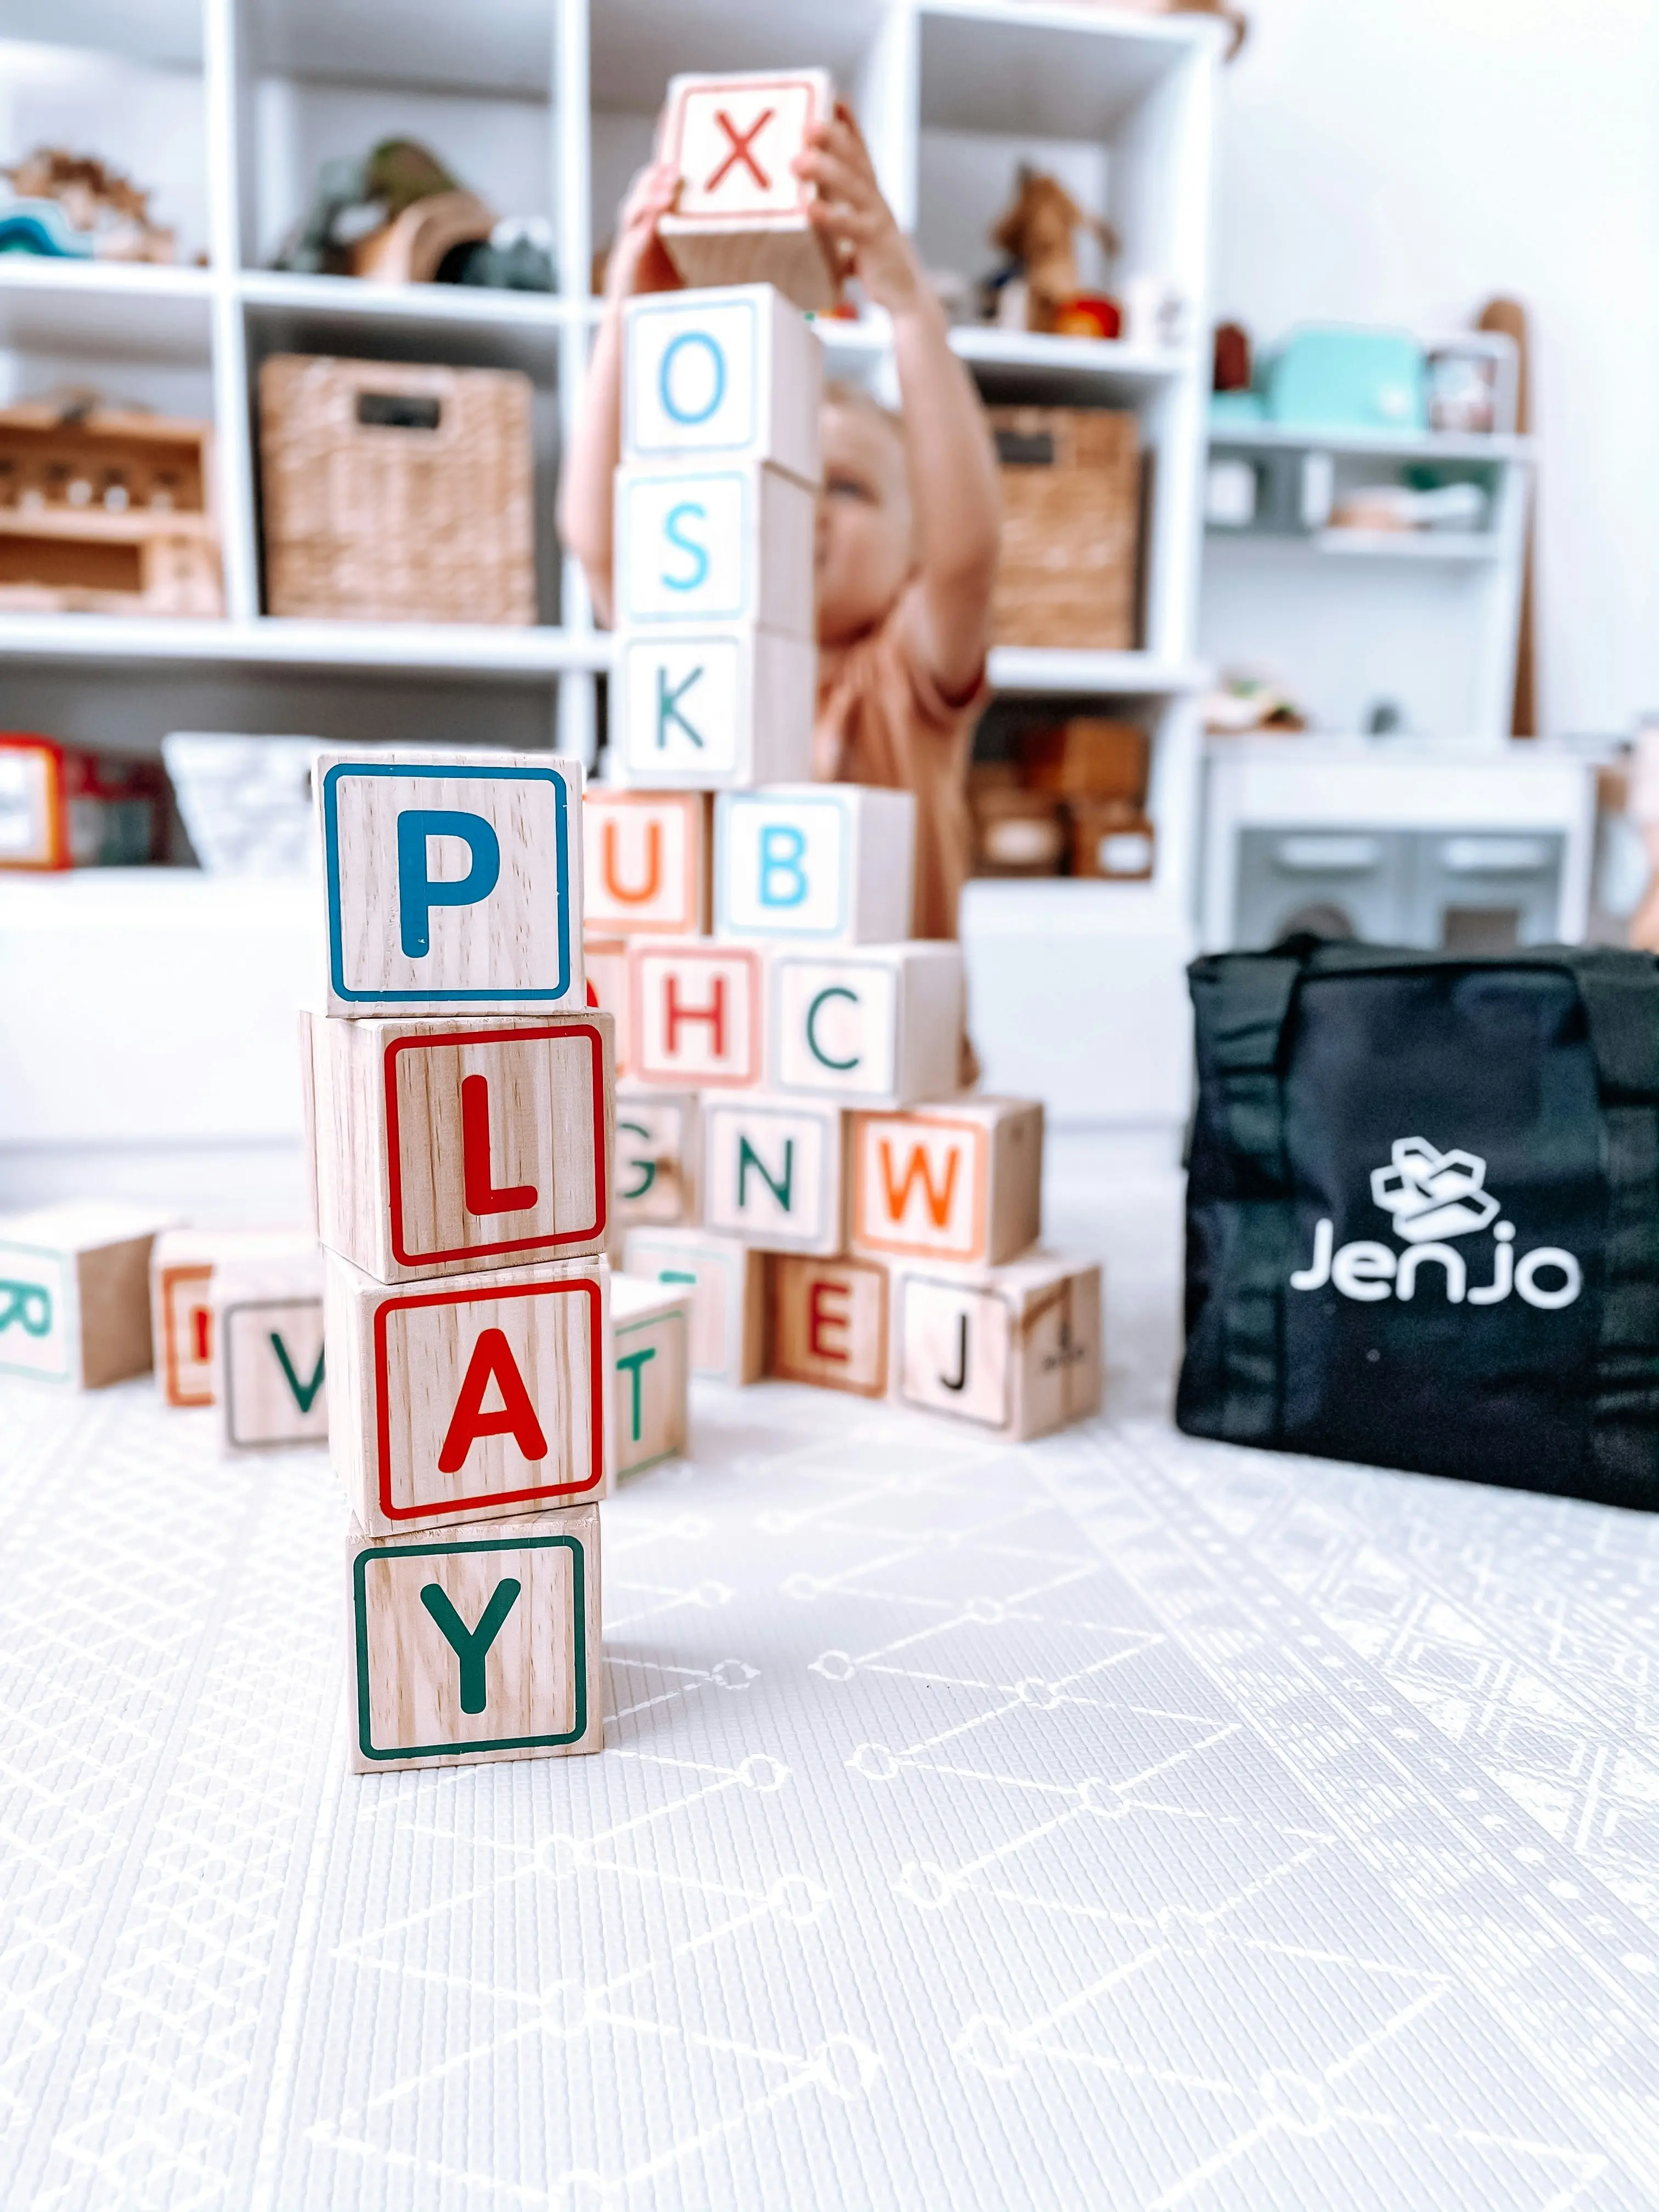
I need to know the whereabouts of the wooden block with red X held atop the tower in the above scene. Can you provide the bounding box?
[657,69,840,309]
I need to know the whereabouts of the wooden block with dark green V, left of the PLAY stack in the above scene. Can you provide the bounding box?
[208,1250,328,1451]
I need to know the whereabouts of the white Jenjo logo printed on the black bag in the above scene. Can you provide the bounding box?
[1290,1137,1584,1314]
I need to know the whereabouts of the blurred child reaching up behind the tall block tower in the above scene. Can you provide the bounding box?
[560,109,997,969]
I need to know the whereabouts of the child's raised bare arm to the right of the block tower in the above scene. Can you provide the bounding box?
[794,106,1002,699]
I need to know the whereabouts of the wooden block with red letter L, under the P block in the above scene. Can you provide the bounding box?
[309,1011,615,1283]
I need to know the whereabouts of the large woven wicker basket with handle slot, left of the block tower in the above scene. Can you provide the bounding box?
[259,354,535,622]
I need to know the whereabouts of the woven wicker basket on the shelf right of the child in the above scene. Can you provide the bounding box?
[991,407,1142,652]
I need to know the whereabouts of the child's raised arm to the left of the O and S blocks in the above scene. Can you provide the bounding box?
[560,161,679,624]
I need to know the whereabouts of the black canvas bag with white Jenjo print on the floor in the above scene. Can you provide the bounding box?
[1175,938,1659,1509]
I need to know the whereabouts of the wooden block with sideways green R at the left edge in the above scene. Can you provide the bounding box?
[0,1199,163,1389]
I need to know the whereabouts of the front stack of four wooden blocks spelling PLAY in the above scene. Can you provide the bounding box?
[303,752,615,1772]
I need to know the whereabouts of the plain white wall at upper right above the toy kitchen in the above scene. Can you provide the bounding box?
[1215,0,1659,732]
